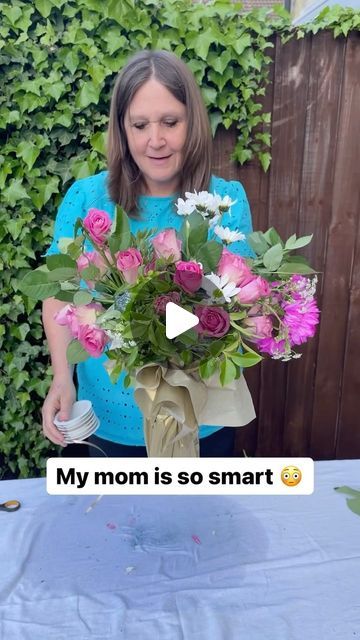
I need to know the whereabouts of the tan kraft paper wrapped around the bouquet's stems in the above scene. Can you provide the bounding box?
[134,364,255,458]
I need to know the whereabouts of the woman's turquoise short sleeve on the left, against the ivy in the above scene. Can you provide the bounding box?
[44,180,86,256]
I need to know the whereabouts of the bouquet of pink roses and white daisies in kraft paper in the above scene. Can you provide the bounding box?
[22,192,319,456]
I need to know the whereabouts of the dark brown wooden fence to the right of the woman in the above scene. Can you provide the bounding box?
[214,32,360,459]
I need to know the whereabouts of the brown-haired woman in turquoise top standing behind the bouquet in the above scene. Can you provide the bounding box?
[43,51,252,457]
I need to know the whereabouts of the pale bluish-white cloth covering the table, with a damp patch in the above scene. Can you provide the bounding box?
[0,460,360,640]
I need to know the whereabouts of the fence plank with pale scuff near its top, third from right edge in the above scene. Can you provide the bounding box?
[257,33,310,455]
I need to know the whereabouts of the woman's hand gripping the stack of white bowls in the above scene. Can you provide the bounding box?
[42,372,76,447]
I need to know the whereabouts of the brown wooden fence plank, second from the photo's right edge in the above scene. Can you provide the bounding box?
[283,32,344,456]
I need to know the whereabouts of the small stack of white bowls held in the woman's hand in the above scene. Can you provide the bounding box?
[54,400,100,444]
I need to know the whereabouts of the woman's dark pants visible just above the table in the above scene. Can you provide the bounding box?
[88,427,235,458]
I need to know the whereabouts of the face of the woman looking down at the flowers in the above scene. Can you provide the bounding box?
[125,79,187,196]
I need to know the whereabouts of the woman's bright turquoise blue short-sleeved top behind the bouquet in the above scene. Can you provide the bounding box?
[46,171,252,446]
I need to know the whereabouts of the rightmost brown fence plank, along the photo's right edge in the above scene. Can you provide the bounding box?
[311,32,360,458]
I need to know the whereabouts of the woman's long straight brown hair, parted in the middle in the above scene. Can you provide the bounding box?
[107,51,212,217]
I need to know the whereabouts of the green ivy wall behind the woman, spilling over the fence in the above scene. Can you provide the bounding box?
[0,0,360,477]
